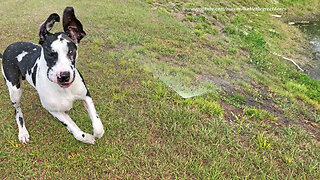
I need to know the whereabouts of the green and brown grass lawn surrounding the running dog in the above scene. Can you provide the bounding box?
[0,0,320,179]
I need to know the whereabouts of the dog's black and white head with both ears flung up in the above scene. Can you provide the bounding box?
[39,7,86,88]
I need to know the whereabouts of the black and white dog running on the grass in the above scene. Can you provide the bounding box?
[0,7,104,144]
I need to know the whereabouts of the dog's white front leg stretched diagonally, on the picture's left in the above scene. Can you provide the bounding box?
[50,112,95,144]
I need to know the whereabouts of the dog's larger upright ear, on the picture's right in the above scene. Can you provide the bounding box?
[63,7,86,43]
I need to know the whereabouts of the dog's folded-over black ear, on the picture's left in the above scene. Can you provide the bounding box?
[39,13,60,44]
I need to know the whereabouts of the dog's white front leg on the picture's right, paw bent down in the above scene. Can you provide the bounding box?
[82,96,104,138]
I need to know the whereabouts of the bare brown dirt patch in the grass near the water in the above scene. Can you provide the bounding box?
[198,72,320,141]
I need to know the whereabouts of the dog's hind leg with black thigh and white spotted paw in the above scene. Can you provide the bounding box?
[2,66,30,143]
